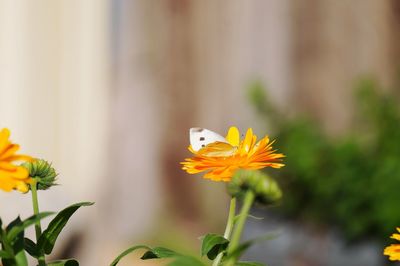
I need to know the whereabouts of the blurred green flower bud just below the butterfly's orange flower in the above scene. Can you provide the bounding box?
[228,170,282,205]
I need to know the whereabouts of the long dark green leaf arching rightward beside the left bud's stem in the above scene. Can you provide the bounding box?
[37,202,93,254]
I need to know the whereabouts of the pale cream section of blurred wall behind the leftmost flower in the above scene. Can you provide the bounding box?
[0,0,110,255]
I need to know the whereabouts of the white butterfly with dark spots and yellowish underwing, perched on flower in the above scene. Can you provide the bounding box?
[189,127,237,156]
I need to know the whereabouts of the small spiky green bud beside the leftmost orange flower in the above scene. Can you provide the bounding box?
[22,159,57,190]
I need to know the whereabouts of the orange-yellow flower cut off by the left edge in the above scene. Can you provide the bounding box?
[0,128,32,193]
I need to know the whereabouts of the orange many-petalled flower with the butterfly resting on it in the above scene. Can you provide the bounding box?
[181,127,284,182]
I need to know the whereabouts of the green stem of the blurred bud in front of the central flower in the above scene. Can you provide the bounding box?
[224,190,255,266]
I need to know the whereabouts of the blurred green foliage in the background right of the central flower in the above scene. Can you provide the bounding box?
[249,80,400,242]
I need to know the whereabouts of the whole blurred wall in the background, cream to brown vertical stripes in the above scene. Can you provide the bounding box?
[0,0,399,265]
